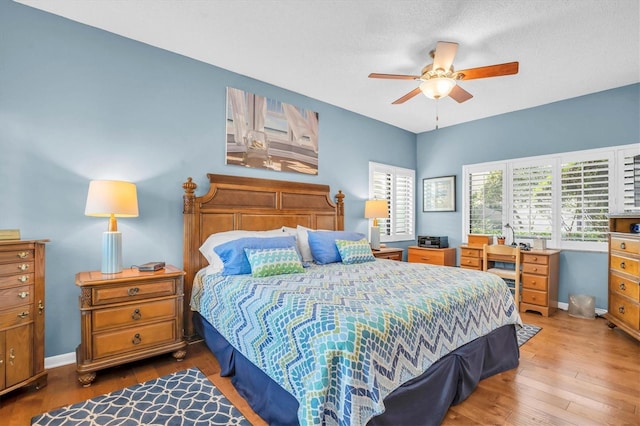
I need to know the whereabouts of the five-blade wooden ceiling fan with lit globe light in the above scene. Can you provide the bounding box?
[369,41,518,104]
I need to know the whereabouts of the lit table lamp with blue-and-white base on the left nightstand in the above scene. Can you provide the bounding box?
[84,180,138,274]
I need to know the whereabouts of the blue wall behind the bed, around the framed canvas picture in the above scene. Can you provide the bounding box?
[0,0,416,356]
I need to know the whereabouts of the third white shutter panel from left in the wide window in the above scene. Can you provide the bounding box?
[561,158,609,241]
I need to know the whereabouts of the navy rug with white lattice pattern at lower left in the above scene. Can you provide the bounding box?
[31,368,251,426]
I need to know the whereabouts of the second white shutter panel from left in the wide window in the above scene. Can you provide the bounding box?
[511,164,553,239]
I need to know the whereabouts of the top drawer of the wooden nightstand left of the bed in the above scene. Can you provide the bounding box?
[92,280,176,306]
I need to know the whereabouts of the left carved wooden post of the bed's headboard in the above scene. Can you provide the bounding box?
[182,178,199,341]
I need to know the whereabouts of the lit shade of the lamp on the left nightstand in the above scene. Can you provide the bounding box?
[84,180,138,217]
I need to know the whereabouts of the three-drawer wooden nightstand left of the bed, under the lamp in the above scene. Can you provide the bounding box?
[76,265,187,386]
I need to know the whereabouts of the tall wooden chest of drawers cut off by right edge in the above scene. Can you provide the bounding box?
[605,214,640,340]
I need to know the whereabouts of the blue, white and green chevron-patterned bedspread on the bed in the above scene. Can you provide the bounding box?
[192,259,522,425]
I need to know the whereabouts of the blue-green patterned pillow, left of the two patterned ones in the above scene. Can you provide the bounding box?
[244,247,304,277]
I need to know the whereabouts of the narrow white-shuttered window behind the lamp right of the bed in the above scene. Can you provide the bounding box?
[369,162,416,242]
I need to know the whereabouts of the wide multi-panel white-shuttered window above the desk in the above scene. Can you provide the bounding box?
[462,144,640,251]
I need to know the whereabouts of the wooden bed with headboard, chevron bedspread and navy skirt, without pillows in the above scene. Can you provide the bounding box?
[183,174,521,425]
